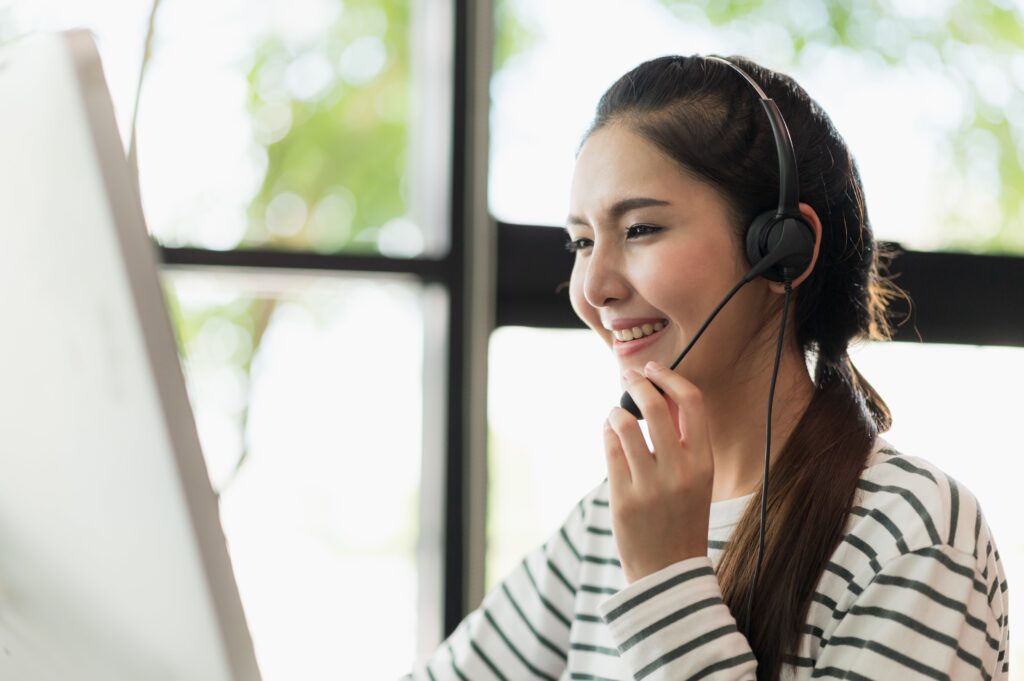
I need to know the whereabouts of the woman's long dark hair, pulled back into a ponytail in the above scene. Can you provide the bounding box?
[581,56,903,681]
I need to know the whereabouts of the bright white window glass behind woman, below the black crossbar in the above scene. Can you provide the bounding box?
[486,327,1024,679]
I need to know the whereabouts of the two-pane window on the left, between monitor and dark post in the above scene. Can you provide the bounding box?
[0,0,468,681]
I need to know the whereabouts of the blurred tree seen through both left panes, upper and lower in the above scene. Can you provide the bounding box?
[167,0,415,492]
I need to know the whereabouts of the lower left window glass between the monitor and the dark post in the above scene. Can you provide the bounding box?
[165,271,423,681]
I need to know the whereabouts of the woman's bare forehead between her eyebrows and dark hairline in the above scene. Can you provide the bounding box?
[569,124,701,222]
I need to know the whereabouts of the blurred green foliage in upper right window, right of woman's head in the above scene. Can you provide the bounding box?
[658,0,1024,253]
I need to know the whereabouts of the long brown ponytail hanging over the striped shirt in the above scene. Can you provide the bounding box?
[718,353,890,681]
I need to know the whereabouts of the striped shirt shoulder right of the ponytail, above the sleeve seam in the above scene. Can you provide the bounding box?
[848,437,995,569]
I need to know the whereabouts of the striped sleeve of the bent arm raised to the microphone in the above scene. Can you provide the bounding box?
[600,546,1009,681]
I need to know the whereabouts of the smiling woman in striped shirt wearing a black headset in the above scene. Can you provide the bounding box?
[405,56,1009,681]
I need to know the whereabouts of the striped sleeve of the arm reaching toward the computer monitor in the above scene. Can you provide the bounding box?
[404,497,589,681]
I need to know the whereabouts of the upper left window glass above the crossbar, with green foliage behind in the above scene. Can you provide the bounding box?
[0,0,423,257]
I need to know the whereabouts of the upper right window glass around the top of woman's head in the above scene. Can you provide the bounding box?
[489,0,1024,253]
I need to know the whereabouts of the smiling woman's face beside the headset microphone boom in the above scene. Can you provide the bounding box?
[566,124,770,389]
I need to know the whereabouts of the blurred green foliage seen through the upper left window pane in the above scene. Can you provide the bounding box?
[244,0,411,252]
